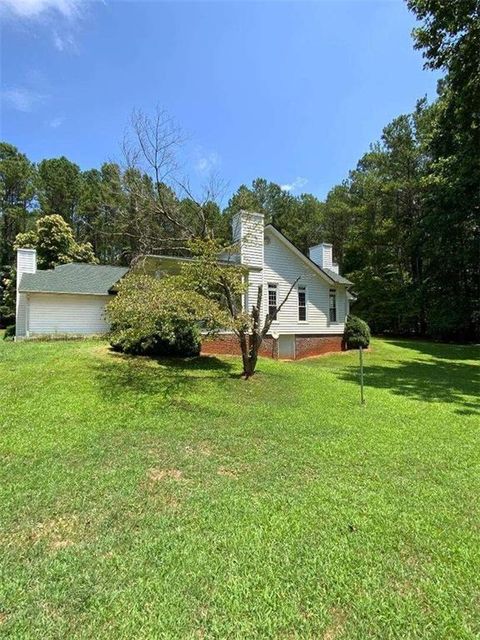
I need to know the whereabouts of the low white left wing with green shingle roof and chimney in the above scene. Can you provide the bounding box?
[16,249,128,338]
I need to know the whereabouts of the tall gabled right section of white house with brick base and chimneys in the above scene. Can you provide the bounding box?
[202,212,353,359]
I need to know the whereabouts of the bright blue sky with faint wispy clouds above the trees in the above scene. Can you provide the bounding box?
[1,0,438,197]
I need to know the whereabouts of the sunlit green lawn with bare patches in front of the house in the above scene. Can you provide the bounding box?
[0,340,480,640]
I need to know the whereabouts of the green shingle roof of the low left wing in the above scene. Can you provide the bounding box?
[18,262,128,295]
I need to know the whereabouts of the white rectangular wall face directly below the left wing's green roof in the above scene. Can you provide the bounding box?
[27,293,111,335]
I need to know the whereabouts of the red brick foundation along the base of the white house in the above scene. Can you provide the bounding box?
[202,334,345,360]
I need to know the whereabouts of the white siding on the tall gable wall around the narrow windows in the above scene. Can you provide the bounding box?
[262,232,347,334]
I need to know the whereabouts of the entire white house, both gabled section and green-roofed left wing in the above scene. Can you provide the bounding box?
[16,211,352,359]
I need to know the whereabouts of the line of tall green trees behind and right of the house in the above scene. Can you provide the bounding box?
[0,0,480,340]
